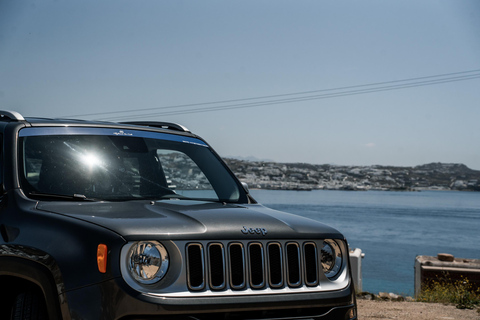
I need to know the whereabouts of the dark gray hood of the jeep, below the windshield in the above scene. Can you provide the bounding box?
[37,200,343,240]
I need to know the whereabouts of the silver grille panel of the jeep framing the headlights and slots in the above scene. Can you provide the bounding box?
[121,239,351,297]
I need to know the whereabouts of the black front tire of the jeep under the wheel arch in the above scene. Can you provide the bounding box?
[11,291,48,320]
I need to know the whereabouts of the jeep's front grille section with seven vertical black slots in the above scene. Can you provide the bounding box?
[186,241,321,291]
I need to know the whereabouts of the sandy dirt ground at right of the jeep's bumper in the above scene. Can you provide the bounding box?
[357,299,480,320]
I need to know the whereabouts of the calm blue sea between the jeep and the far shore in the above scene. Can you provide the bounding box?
[251,190,480,295]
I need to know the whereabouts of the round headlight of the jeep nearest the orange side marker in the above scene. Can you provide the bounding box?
[127,241,168,284]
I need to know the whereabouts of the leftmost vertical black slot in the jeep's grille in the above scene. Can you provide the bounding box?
[187,243,205,290]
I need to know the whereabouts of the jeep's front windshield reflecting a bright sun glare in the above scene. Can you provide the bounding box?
[19,127,247,202]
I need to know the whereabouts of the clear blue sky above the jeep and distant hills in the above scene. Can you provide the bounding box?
[0,0,480,170]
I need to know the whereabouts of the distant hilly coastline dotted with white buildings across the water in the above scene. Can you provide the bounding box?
[224,158,480,191]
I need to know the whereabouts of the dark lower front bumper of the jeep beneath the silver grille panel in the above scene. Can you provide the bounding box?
[64,279,356,320]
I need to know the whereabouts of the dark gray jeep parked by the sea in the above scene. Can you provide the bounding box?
[0,111,356,320]
